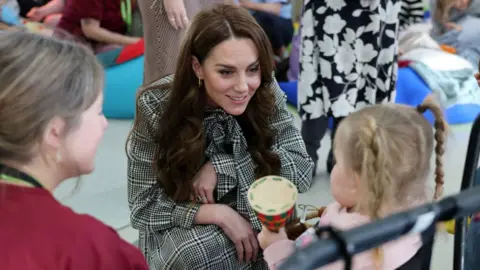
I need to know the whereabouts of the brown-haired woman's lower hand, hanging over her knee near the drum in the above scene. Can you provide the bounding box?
[219,205,258,263]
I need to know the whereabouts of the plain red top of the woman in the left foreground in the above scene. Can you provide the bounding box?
[0,184,148,270]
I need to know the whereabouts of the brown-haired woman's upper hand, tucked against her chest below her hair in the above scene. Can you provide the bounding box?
[190,161,217,203]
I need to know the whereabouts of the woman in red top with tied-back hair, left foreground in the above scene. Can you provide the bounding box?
[0,31,148,270]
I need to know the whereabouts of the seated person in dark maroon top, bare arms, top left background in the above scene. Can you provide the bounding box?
[30,0,140,52]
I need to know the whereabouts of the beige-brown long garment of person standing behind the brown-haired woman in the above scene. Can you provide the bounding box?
[138,0,228,84]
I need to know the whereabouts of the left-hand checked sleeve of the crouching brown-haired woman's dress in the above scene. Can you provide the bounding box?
[127,90,200,232]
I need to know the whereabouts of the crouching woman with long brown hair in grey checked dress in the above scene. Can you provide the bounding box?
[127,5,313,270]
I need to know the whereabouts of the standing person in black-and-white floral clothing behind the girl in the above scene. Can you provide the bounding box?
[298,0,423,173]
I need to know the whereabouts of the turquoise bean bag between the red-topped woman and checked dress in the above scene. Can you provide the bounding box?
[103,56,143,119]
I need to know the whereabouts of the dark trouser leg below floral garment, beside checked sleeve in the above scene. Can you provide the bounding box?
[301,116,328,176]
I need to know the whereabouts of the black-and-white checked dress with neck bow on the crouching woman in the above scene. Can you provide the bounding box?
[128,76,313,270]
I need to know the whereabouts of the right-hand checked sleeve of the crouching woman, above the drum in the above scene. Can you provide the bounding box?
[272,77,314,192]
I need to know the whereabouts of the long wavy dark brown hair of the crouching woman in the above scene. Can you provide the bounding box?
[154,4,280,201]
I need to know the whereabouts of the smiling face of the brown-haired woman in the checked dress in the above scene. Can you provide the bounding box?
[193,38,262,115]
